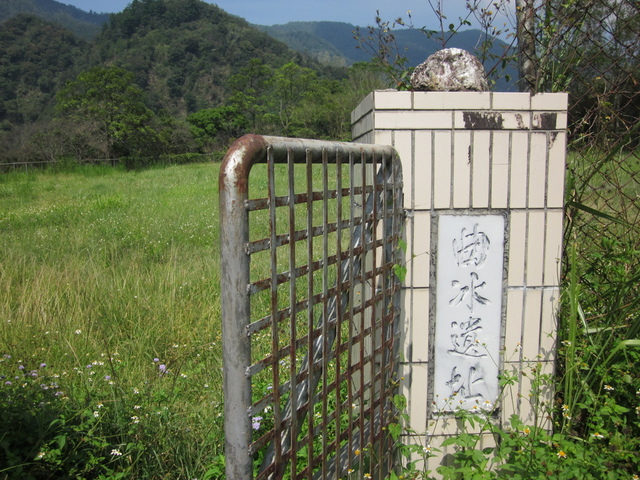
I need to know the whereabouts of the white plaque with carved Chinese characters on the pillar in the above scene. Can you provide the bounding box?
[434,215,505,411]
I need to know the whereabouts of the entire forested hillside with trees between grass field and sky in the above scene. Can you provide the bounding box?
[0,0,385,162]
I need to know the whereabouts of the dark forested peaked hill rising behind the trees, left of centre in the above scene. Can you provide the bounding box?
[92,0,338,117]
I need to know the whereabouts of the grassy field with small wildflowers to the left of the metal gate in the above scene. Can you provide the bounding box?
[0,164,228,478]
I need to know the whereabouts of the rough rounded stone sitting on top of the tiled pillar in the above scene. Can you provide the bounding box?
[411,48,489,92]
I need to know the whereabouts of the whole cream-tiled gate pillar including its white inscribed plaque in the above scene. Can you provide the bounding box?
[352,91,567,469]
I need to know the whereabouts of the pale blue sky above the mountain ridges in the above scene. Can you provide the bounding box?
[58,0,515,29]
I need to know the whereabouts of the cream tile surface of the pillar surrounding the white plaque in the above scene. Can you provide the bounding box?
[352,87,567,468]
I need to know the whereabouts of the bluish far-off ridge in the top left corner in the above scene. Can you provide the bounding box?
[0,0,109,40]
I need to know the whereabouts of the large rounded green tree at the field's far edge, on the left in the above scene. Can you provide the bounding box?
[57,67,160,158]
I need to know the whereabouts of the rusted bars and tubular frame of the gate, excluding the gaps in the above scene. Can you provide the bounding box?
[220,135,403,479]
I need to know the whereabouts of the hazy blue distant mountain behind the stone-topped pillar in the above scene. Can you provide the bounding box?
[256,22,517,91]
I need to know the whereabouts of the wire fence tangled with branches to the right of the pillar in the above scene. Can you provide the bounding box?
[518,0,640,308]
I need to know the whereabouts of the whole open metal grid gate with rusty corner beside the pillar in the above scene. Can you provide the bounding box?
[219,135,403,480]
